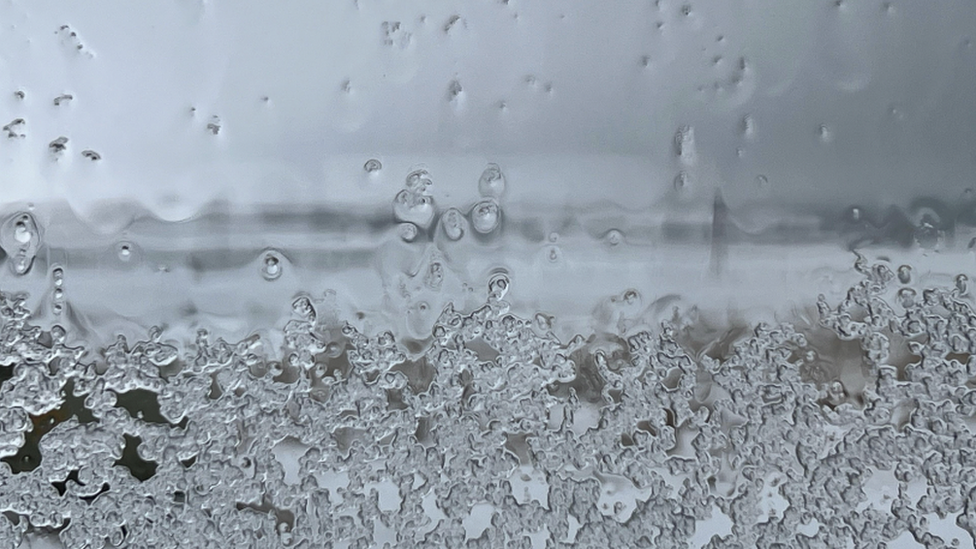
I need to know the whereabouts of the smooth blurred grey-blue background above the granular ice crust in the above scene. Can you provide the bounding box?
[0,0,976,346]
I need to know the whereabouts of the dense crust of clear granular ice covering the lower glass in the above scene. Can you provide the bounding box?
[0,262,976,548]
